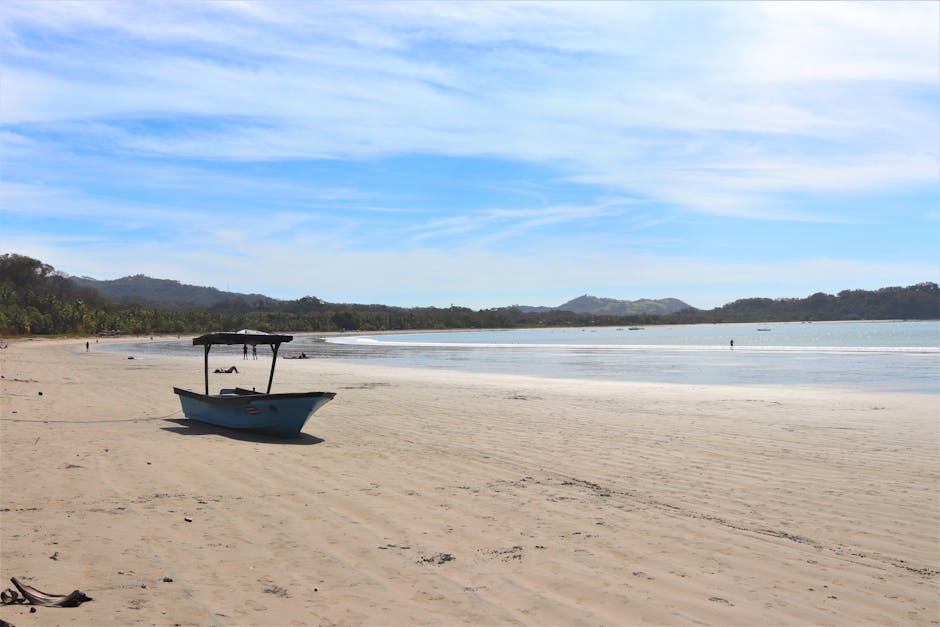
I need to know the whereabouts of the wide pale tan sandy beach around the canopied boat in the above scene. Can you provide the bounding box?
[0,340,940,626]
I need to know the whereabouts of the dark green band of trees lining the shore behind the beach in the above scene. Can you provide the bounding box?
[0,254,940,335]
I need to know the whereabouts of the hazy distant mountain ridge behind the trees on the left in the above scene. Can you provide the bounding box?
[69,274,283,309]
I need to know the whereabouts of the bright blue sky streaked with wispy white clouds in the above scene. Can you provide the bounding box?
[0,1,940,309]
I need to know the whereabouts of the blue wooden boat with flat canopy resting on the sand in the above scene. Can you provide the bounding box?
[173,329,336,438]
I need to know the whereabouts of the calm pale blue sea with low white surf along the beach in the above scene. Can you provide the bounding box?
[114,320,940,394]
